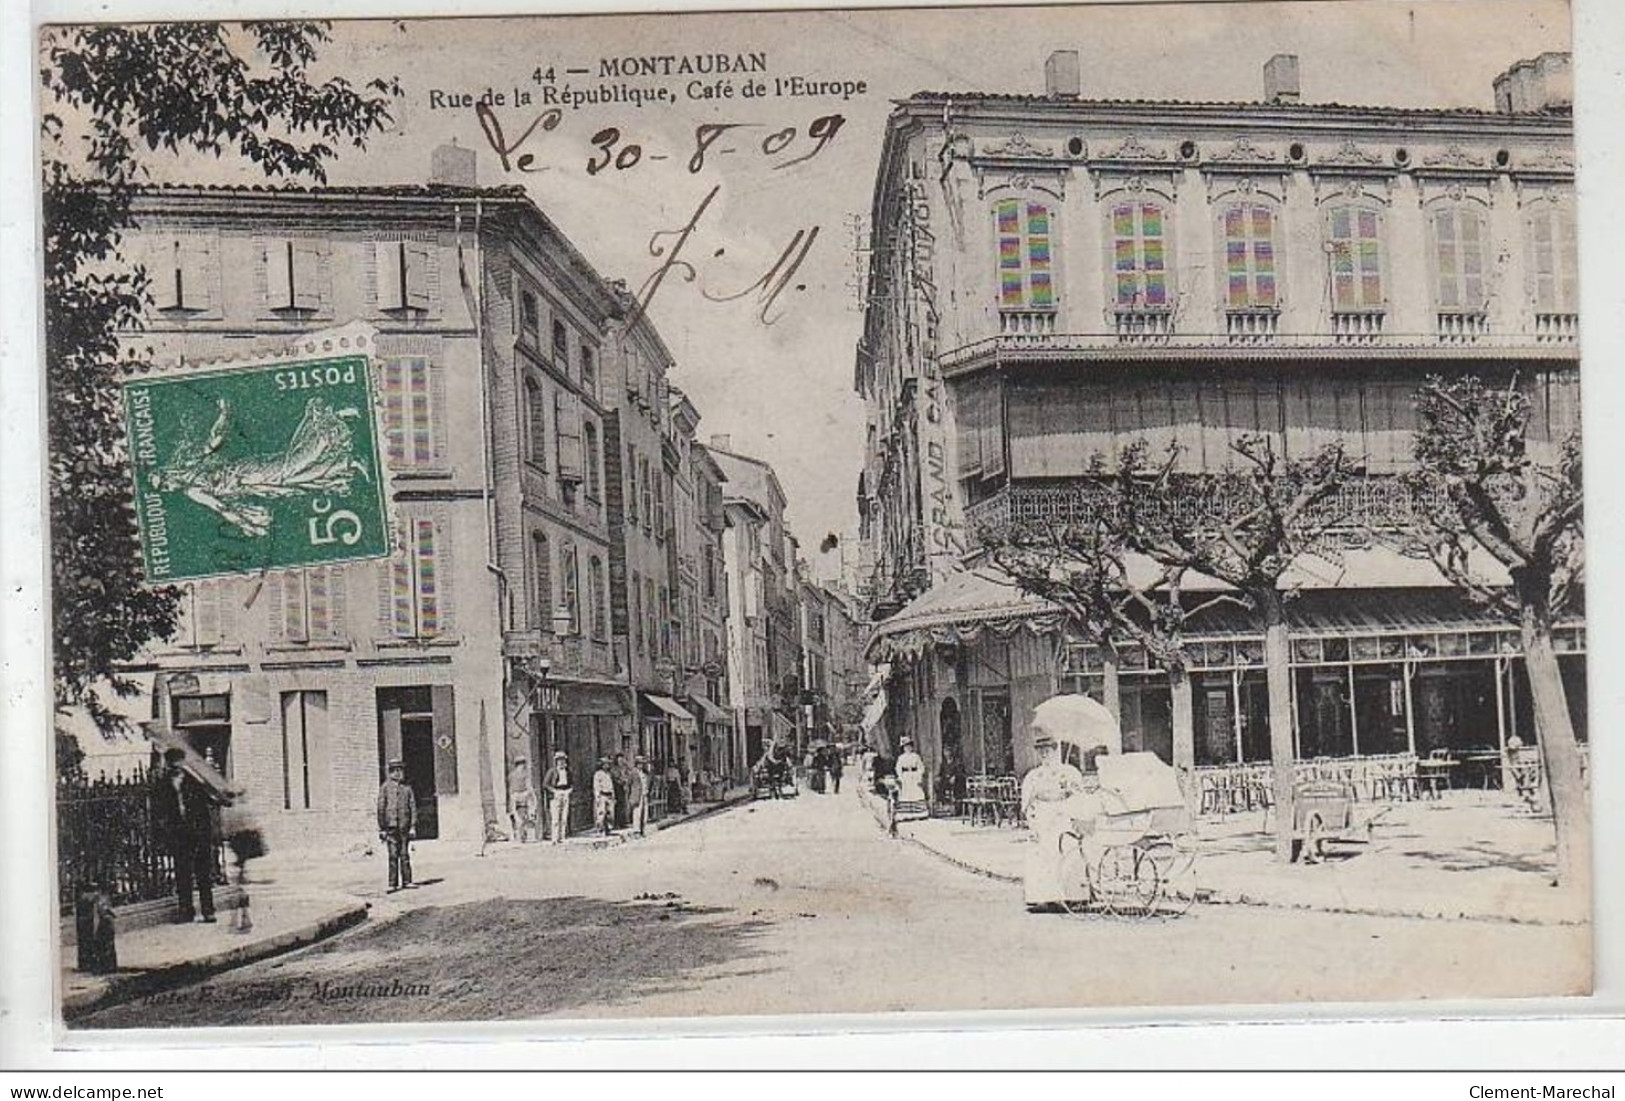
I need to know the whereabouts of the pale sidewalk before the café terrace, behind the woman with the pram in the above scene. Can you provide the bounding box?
[865,791,1591,926]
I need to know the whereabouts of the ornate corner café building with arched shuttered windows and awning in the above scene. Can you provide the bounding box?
[856,50,1584,792]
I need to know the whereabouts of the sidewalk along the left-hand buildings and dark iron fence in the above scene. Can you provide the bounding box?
[62,788,751,1021]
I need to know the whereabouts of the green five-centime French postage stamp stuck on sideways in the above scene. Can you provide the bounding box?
[124,354,390,583]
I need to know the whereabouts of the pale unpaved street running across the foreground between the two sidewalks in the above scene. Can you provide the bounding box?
[75,788,1588,1028]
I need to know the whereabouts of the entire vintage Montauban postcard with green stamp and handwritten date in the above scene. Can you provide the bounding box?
[37,0,1594,1033]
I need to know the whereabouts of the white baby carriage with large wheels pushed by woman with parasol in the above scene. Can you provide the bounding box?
[1061,753,1201,918]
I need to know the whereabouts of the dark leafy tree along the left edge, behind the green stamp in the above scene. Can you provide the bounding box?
[39,23,400,728]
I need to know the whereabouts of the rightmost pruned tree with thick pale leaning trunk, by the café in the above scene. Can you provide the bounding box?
[1407,375,1591,883]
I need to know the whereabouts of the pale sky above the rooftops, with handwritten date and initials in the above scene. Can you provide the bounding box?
[76,0,1570,568]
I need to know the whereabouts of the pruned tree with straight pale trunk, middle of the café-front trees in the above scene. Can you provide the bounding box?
[1116,435,1352,862]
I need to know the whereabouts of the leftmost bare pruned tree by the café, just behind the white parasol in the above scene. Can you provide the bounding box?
[983,509,1242,797]
